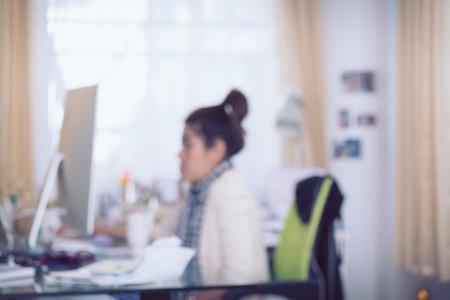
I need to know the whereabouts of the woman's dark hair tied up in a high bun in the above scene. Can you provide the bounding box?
[186,89,248,158]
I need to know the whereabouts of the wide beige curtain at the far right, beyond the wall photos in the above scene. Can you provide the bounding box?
[395,0,450,280]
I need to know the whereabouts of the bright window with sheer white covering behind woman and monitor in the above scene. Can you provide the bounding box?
[36,0,281,204]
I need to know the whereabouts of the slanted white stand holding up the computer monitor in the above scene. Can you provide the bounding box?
[27,152,64,250]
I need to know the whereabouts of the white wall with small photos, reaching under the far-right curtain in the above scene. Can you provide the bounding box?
[322,0,450,300]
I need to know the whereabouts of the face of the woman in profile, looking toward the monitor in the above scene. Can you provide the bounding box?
[178,125,224,182]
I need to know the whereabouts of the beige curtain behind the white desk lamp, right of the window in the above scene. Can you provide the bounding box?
[275,0,328,168]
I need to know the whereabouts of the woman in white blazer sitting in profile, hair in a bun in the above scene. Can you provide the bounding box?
[177,89,269,284]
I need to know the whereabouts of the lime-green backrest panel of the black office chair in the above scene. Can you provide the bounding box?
[273,177,333,280]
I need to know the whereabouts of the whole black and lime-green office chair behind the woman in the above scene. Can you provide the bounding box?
[225,176,343,300]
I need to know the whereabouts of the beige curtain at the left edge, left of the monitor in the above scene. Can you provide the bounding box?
[0,0,35,208]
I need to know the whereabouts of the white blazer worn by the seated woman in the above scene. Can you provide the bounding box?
[199,168,269,283]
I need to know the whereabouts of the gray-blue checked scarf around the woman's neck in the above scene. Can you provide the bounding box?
[177,160,232,283]
